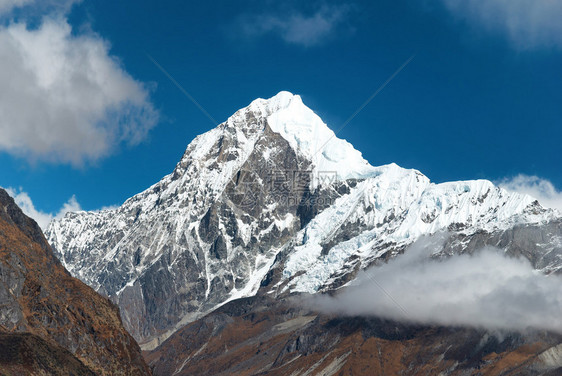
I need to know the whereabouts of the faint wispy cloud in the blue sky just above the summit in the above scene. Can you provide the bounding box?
[242,5,350,47]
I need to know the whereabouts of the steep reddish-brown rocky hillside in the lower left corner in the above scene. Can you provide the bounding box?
[0,189,150,375]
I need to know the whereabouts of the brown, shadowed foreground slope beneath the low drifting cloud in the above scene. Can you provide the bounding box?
[146,297,562,376]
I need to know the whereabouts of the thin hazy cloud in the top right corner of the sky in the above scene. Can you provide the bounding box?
[441,0,562,49]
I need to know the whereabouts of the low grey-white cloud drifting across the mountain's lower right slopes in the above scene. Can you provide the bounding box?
[308,241,562,333]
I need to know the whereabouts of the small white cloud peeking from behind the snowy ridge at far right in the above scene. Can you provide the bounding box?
[498,174,562,212]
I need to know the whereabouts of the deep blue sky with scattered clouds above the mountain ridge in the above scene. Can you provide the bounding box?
[0,0,562,226]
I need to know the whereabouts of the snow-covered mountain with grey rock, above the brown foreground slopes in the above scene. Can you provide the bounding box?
[46,92,562,349]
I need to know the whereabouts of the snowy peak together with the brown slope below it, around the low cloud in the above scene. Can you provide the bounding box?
[41,92,562,375]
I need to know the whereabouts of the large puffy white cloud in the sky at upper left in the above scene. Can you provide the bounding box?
[0,17,158,165]
